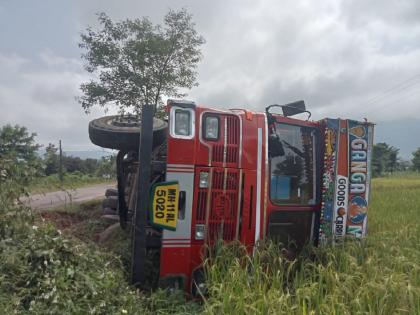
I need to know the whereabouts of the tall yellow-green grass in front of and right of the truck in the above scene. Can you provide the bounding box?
[204,176,420,314]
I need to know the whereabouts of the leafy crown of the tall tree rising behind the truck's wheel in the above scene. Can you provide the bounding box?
[78,9,204,113]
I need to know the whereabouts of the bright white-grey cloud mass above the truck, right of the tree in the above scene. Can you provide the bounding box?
[51,0,420,120]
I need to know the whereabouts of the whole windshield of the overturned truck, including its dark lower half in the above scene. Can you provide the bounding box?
[266,118,322,249]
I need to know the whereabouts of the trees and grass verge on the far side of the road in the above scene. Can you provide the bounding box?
[0,125,116,194]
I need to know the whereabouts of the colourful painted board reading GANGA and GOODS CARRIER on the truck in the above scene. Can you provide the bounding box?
[319,118,374,244]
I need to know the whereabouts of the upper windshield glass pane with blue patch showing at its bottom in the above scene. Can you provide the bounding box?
[268,123,316,205]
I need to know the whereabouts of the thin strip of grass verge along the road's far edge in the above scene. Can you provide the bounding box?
[28,173,115,194]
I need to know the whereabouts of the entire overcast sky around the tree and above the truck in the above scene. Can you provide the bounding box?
[0,0,420,158]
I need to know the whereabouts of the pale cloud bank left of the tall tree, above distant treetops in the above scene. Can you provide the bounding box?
[0,51,110,150]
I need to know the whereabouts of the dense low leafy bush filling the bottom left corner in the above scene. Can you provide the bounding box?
[0,225,141,314]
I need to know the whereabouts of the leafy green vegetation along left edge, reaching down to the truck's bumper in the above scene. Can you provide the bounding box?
[0,147,198,314]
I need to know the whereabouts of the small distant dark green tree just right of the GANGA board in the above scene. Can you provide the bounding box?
[372,142,399,177]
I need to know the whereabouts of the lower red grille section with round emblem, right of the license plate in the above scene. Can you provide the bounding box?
[193,169,239,244]
